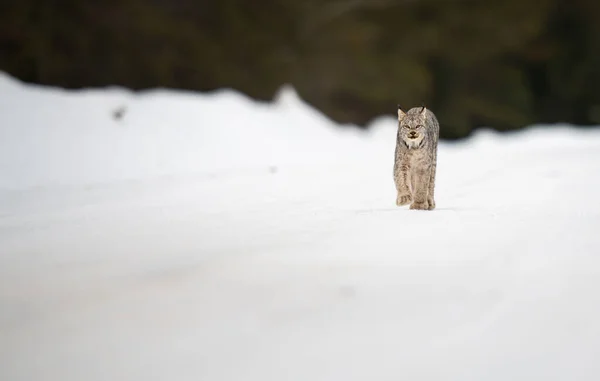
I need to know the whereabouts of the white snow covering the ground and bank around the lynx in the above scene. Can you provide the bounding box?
[0,74,600,381]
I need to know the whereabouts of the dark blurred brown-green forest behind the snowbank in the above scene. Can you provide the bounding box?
[0,0,600,139]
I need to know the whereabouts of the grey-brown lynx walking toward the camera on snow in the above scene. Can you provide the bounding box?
[394,106,440,210]
